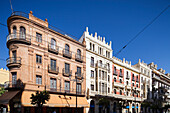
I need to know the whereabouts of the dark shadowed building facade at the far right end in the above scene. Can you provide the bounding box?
[148,62,170,113]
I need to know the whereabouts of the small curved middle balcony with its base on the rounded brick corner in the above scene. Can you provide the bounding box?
[6,57,21,68]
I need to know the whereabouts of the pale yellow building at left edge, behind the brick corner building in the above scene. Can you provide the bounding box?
[0,68,9,85]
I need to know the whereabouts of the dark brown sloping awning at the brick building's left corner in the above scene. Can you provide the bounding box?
[0,91,19,104]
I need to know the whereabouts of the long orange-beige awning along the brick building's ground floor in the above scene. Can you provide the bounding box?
[21,91,89,107]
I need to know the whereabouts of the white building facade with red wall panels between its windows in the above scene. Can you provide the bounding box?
[112,57,141,113]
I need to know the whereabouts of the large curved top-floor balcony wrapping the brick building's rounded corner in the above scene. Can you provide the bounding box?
[7,33,32,48]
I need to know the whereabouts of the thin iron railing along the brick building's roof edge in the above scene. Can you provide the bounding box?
[11,11,79,41]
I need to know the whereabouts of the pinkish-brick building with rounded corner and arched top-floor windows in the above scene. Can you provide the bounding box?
[1,11,88,113]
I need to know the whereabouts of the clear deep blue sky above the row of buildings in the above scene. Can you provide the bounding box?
[0,0,170,72]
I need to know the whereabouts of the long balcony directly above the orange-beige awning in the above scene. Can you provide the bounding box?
[47,86,85,95]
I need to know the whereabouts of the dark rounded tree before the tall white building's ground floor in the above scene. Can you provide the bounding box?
[97,98,110,113]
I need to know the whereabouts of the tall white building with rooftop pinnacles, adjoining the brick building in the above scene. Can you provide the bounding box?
[80,27,112,113]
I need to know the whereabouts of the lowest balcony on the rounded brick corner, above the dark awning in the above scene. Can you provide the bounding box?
[4,80,24,90]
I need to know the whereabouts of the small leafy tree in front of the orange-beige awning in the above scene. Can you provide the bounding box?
[30,91,50,112]
